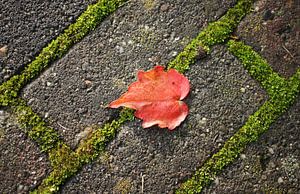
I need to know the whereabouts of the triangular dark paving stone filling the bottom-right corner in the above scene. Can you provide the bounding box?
[204,99,300,193]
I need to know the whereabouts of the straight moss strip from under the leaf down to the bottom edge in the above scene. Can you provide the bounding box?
[33,108,134,193]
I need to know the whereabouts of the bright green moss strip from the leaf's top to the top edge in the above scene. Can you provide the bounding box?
[168,0,253,73]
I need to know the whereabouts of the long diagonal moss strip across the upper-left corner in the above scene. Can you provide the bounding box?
[0,0,126,106]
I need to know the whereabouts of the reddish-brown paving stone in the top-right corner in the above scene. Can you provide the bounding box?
[237,0,300,77]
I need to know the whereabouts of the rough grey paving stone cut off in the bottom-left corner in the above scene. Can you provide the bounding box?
[0,109,50,193]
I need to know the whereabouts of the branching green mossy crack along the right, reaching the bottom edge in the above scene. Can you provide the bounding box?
[176,41,300,193]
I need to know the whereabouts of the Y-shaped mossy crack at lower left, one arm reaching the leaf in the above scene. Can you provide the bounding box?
[8,96,134,193]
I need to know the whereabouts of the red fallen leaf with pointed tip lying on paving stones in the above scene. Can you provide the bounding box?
[109,66,190,130]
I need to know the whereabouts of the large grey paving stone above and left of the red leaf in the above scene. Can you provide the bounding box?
[22,0,238,147]
